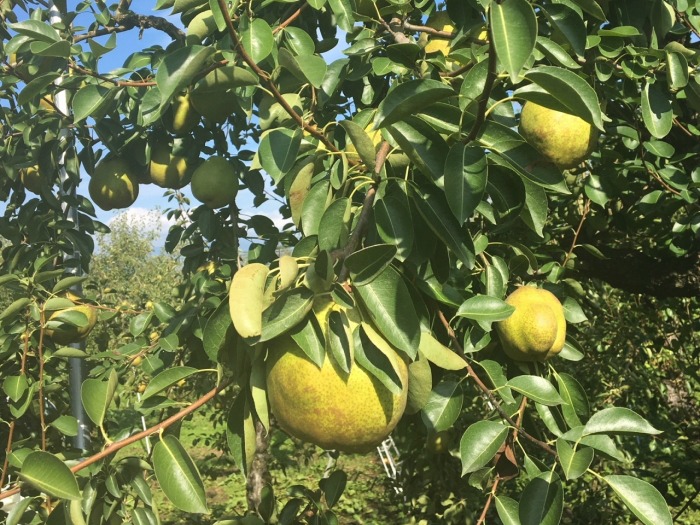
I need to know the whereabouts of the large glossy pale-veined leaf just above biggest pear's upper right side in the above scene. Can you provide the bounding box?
[355,266,420,358]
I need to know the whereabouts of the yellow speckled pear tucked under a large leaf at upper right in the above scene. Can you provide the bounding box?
[518,102,598,170]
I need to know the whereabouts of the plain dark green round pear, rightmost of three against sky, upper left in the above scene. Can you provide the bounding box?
[190,157,238,209]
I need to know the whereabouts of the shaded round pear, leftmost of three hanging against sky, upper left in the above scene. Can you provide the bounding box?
[88,158,139,211]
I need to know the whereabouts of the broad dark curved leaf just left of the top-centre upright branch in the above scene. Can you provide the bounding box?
[374,79,455,129]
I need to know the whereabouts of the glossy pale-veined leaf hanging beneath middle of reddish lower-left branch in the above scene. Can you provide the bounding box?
[153,434,209,514]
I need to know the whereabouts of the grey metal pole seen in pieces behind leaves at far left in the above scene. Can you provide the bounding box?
[49,2,90,451]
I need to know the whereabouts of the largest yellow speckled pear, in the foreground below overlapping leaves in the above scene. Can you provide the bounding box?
[266,336,408,453]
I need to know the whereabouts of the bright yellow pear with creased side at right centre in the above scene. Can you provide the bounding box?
[496,286,566,361]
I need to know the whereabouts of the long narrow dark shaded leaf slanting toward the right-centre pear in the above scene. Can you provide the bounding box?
[413,191,475,269]
